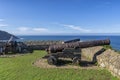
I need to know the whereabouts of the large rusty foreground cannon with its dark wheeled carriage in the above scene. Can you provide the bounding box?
[43,39,110,64]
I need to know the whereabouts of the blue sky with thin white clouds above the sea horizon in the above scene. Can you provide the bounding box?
[0,0,120,35]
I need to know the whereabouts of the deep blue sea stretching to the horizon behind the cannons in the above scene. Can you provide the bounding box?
[18,35,120,51]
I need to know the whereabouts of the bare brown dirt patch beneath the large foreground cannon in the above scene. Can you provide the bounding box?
[33,57,98,69]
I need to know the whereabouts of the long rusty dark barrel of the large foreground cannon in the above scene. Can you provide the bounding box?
[48,39,110,53]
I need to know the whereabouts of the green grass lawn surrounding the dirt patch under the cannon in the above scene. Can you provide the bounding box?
[0,51,118,80]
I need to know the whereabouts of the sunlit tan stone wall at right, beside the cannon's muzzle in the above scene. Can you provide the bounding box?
[82,46,120,78]
